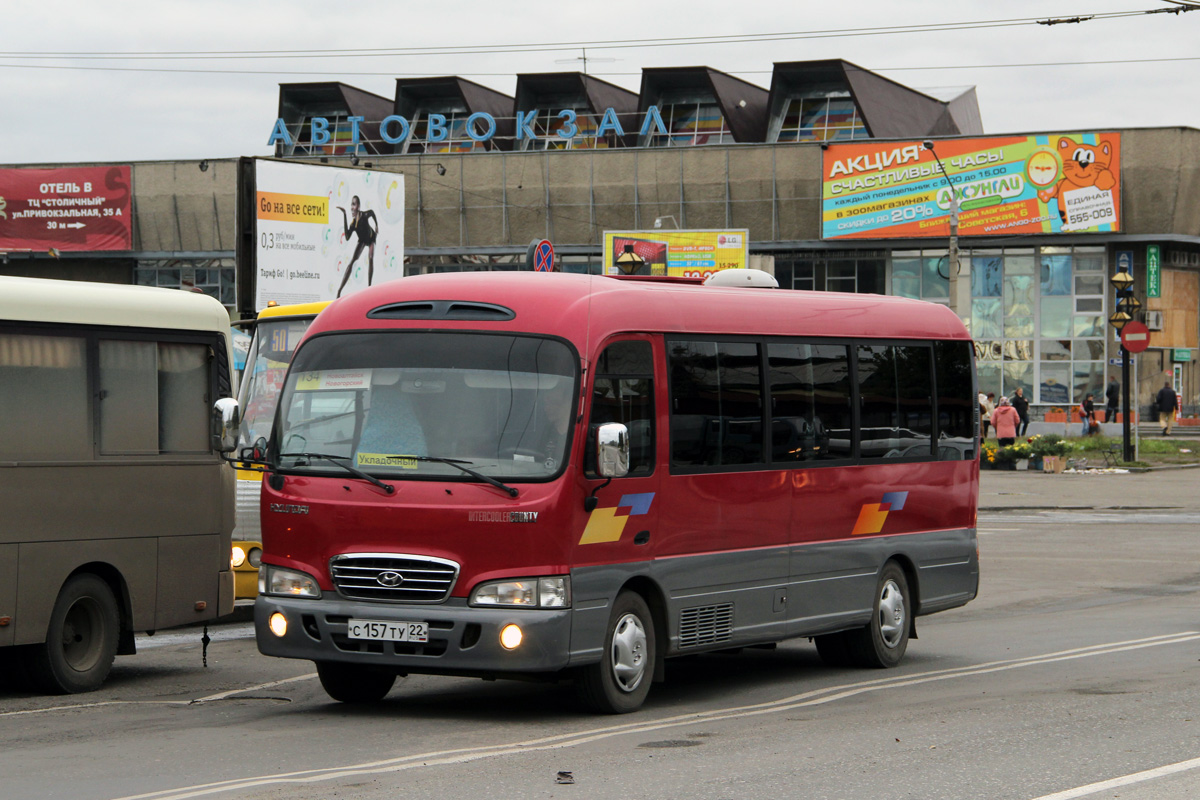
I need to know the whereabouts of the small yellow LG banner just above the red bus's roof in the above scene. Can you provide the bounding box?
[604,229,750,278]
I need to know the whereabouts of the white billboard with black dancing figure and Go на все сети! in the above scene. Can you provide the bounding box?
[253,160,404,309]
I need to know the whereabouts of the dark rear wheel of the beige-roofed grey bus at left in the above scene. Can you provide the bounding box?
[29,573,121,694]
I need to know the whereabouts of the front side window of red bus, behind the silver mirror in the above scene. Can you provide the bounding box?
[584,341,654,475]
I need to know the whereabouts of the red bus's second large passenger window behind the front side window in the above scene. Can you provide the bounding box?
[767,342,852,463]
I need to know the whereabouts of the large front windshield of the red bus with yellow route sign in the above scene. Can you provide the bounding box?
[271,331,578,481]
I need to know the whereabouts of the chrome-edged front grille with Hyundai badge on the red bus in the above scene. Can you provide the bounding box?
[329,553,458,603]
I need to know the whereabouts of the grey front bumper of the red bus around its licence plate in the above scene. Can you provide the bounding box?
[254,595,571,676]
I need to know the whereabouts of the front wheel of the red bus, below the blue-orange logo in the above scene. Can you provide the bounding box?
[575,591,655,714]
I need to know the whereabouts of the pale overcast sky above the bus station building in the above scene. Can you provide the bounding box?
[0,0,1200,164]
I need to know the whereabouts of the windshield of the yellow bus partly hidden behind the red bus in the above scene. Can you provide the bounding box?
[238,317,313,446]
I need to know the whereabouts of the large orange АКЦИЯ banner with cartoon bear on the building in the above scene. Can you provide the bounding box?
[821,133,1121,239]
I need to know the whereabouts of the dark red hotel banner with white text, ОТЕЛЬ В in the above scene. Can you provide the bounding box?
[0,164,133,252]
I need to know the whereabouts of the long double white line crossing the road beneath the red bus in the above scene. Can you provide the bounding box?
[105,631,1200,800]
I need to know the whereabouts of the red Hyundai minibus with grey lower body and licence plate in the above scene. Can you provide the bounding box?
[248,272,979,712]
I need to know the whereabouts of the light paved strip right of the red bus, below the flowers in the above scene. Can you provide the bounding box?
[979,469,1200,511]
